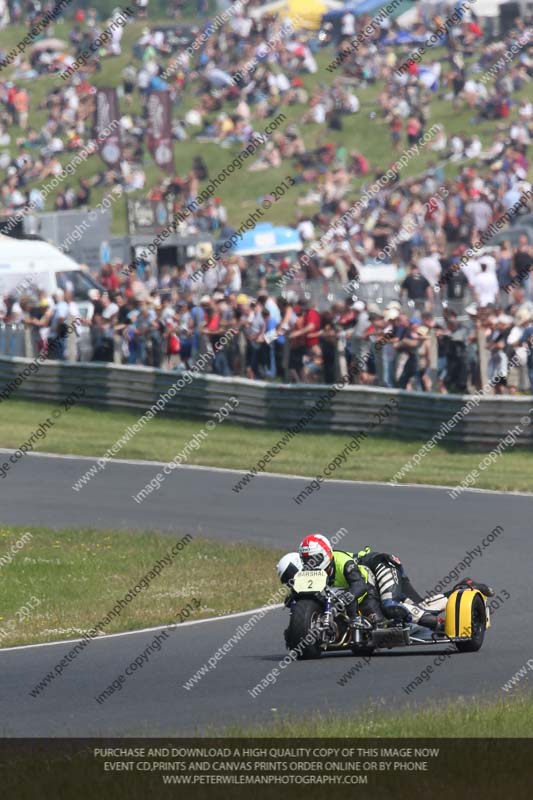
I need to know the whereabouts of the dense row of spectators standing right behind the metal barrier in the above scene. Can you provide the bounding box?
[4,260,533,393]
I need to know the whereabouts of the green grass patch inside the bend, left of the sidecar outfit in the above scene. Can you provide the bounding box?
[0,528,281,647]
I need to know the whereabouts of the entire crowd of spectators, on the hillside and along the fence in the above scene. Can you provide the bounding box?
[0,0,533,391]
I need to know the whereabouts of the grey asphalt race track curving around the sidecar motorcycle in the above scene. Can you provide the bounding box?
[0,455,533,736]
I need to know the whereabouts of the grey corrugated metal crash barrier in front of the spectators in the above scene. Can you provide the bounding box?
[0,356,533,447]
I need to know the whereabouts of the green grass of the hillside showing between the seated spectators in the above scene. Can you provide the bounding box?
[0,19,533,235]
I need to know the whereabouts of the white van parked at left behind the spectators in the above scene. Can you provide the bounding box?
[0,235,102,316]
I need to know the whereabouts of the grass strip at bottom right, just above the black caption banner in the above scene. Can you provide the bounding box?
[224,694,533,739]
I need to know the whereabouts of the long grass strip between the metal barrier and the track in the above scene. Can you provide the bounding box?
[0,400,533,491]
